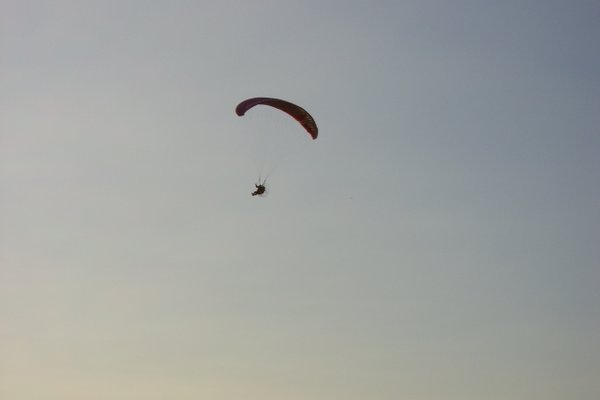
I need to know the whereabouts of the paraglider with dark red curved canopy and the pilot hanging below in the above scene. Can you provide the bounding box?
[235,97,319,197]
